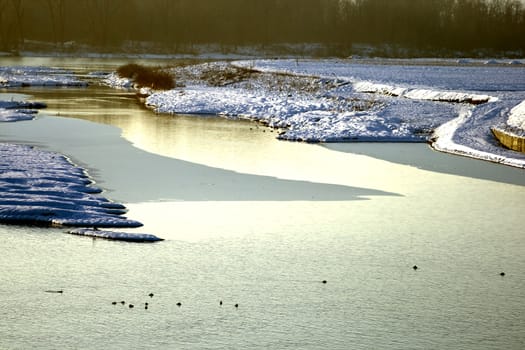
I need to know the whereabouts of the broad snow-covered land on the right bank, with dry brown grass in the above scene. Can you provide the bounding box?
[136,59,525,167]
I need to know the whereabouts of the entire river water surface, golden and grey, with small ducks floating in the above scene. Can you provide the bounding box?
[0,58,525,349]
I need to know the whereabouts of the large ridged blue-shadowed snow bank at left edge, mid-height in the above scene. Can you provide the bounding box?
[0,143,142,227]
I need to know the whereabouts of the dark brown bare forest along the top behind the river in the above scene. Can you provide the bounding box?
[0,0,525,54]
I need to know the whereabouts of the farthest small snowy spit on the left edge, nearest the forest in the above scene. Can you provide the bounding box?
[0,66,88,88]
